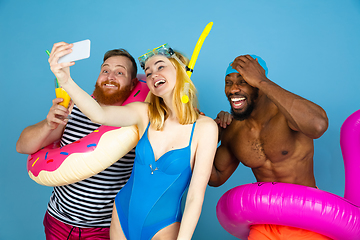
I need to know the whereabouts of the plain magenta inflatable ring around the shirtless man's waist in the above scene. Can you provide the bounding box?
[216,110,360,240]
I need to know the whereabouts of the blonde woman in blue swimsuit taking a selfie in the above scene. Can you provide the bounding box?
[49,44,218,240]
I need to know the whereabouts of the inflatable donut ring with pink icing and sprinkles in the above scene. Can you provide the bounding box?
[27,75,149,186]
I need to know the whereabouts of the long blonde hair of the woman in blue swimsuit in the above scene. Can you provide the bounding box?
[149,51,199,131]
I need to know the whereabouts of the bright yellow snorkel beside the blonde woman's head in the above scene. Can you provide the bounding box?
[181,22,213,103]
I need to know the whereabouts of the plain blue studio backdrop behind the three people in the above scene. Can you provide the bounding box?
[0,0,360,240]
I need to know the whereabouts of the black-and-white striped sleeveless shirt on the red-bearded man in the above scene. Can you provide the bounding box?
[47,106,135,227]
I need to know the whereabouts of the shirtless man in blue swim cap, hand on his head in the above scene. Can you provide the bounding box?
[209,55,328,240]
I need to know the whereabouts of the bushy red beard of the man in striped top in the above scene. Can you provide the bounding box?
[93,81,131,105]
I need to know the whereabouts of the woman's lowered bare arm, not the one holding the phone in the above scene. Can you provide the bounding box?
[177,116,218,240]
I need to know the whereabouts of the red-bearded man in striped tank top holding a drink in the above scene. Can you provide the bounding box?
[16,42,138,240]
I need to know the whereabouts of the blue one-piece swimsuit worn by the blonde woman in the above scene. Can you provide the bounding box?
[115,123,195,240]
